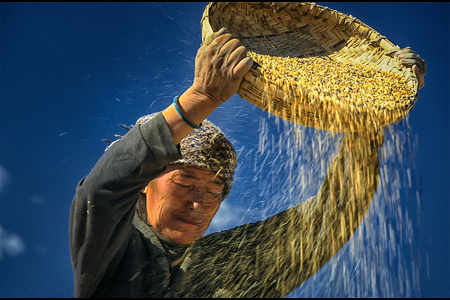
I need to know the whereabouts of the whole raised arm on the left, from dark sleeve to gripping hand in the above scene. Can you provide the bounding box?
[69,29,252,297]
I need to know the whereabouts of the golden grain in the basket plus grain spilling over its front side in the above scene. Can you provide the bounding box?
[248,51,416,131]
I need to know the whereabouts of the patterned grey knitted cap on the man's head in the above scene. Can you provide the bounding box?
[136,113,237,199]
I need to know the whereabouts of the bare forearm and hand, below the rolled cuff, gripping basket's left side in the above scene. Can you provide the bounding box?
[163,28,253,144]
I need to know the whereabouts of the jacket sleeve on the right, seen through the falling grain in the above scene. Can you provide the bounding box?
[186,136,379,297]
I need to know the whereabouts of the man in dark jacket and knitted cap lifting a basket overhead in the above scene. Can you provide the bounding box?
[70,28,425,297]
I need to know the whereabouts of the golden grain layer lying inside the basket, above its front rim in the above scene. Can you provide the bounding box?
[249,51,415,109]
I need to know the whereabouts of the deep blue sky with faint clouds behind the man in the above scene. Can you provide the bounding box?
[0,2,450,297]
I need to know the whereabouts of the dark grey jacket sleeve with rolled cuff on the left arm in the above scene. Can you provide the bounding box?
[69,114,181,297]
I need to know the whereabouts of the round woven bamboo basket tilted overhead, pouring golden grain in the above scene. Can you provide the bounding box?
[201,2,418,132]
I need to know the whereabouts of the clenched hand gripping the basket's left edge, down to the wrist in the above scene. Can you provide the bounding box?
[192,28,253,105]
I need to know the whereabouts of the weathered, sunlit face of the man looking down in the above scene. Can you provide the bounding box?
[144,165,223,244]
